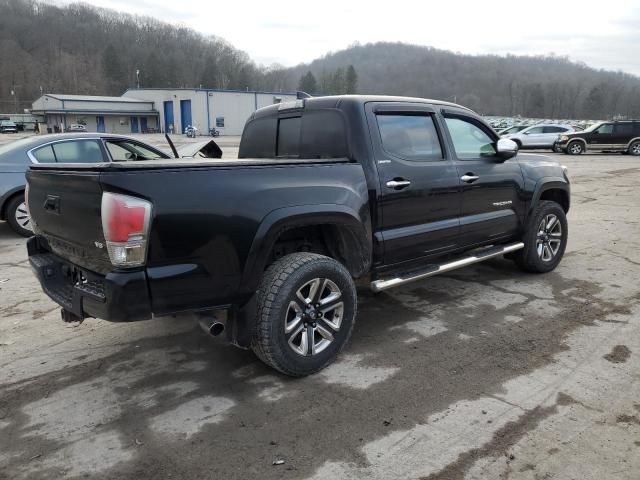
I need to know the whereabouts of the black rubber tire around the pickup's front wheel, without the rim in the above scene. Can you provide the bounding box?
[513,200,569,273]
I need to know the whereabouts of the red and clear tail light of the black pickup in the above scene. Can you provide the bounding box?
[102,192,151,267]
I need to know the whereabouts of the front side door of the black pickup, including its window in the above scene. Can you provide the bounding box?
[443,109,525,247]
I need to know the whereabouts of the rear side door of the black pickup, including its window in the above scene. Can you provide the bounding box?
[367,103,460,266]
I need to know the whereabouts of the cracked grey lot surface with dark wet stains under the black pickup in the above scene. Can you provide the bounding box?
[0,136,640,480]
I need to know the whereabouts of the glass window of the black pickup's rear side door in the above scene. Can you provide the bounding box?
[377,115,443,161]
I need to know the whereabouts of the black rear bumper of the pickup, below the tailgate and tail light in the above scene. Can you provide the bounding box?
[27,237,152,322]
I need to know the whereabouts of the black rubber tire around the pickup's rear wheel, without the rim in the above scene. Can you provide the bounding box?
[251,253,357,377]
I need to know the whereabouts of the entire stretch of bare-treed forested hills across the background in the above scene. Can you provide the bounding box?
[0,0,640,118]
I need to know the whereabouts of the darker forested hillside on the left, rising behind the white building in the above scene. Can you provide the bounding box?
[0,0,269,111]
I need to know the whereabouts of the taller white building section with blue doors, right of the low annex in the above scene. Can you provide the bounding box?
[123,88,296,135]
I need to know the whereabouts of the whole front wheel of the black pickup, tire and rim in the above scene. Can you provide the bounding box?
[514,200,569,273]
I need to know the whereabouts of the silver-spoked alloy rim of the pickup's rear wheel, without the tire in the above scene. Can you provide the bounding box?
[284,278,344,356]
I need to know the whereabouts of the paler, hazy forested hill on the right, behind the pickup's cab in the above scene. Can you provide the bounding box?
[291,43,640,118]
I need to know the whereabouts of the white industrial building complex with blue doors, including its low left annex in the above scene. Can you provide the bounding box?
[31,88,296,135]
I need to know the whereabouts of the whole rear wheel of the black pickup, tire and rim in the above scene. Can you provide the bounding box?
[251,253,357,377]
